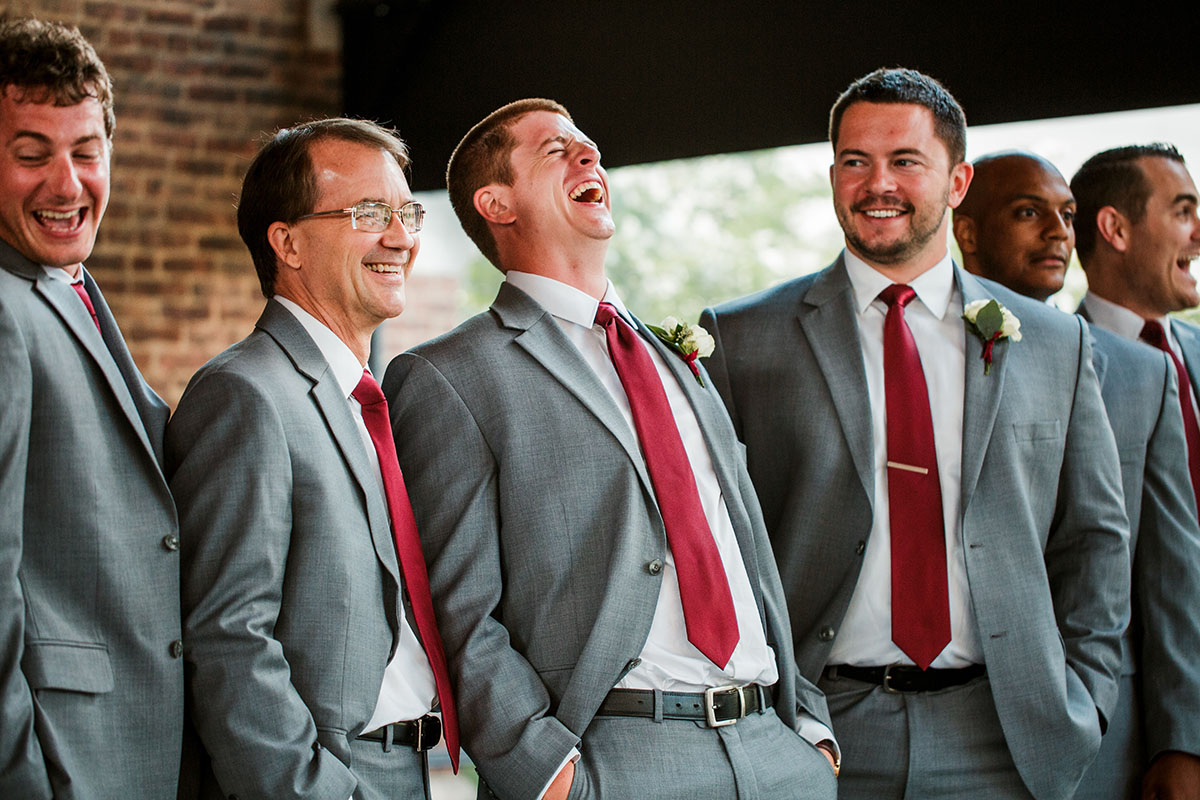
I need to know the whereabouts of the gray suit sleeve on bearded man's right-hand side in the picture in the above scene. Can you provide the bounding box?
[1045,319,1130,730]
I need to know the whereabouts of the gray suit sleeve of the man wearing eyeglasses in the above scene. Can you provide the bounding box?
[167,372,358,798]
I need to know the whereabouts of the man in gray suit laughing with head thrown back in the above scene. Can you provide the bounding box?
[384,100,836,800]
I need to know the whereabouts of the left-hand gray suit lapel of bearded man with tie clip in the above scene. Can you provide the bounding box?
[796,258,875,504]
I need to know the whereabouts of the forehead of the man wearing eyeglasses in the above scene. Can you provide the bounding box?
[308,139,410,206]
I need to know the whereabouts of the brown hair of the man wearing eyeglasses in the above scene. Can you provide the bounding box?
[238,122,408,297]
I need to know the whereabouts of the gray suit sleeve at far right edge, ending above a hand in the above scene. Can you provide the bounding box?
[1133,356,1200,759]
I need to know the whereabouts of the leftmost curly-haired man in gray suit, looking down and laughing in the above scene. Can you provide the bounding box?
[0,19,184,800]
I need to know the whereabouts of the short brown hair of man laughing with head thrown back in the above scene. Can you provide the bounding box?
[446,97,571,270]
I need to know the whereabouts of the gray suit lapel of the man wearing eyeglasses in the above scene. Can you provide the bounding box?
[257,301,400,585]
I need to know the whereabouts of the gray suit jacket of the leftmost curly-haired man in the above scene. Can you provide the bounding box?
[0,242,184,800]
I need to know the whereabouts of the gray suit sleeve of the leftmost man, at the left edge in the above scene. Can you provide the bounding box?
[0,297,53,799]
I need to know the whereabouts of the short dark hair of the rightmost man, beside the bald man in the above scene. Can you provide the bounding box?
[1070,142,1183,262]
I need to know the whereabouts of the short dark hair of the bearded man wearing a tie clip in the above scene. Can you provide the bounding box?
[829,67,967,167]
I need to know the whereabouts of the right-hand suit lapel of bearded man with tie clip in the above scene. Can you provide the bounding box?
[954,264,1013,510]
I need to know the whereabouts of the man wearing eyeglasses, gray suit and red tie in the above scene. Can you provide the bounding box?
[167,119,457,800]
